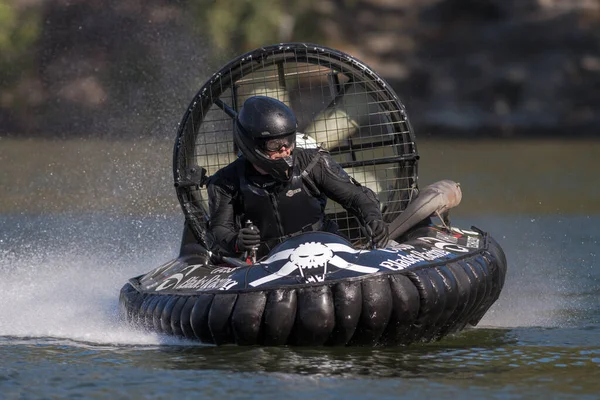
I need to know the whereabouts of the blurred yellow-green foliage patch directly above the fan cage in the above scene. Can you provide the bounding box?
[192,0,321,53]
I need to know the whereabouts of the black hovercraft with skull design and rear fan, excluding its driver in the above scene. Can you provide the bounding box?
[119,43,507,346]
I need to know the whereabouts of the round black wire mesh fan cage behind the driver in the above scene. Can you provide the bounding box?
[173,43,418,247]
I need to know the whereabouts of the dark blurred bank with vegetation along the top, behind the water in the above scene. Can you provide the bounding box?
[0,0,600,138]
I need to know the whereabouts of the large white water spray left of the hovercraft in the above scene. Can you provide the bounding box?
[0,215,190,345]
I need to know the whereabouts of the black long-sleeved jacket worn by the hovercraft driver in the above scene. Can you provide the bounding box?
[207,149,382,255]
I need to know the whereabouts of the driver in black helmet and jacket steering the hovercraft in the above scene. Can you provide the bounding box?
[207,96,389,257]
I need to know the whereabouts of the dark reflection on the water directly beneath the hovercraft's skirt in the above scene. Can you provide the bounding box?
[143,330,514,378]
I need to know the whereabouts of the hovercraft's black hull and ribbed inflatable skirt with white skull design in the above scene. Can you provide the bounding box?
[119,225,506,346]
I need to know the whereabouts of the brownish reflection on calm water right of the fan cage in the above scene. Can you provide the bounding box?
[418,140,600,216]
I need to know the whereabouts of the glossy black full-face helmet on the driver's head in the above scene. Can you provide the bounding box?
[233,96,297,181]
